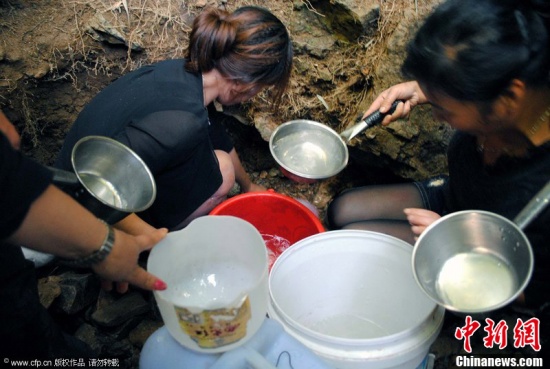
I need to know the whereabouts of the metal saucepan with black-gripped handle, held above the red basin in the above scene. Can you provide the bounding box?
[269,100,401,183]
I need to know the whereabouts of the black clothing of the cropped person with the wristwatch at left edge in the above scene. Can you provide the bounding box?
[0,133,92,360]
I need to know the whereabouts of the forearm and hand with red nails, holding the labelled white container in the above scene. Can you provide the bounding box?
[8,181,167,290]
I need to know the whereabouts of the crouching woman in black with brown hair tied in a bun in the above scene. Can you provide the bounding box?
[55,7,293,232]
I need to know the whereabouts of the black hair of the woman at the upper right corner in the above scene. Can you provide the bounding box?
[402,0,550,103]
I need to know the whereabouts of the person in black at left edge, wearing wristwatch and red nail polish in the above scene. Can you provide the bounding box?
[0,111,167,360]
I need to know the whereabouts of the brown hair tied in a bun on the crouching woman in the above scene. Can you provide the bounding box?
[185,6,293,101]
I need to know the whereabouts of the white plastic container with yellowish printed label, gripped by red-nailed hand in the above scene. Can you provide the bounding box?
[147,216,269,354]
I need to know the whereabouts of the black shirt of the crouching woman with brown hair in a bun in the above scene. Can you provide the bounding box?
[55,60,233,228]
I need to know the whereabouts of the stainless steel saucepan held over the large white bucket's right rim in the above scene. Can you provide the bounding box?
[412,182,550,313]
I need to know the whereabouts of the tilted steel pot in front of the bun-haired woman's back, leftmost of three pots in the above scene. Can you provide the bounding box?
[49,136,157,224]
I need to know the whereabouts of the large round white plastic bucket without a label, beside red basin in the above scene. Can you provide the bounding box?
[268,230,445,369]
